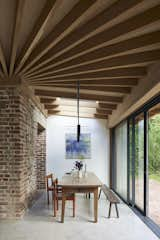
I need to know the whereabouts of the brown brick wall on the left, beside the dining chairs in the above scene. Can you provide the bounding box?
[0,87,45,218]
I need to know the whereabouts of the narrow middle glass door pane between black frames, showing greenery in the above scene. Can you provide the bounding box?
[134,113,144,211]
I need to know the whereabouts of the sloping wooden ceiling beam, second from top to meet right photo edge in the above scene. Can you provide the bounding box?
[24,31,160,76]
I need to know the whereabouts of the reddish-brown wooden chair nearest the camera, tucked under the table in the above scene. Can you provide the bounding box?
[52,178,75,217]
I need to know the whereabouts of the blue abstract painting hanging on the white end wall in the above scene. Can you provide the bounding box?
[65,133,91,160]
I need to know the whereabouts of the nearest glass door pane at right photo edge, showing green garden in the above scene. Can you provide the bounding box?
[147,103,160,226]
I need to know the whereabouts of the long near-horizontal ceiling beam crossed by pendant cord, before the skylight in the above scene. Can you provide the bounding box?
[35,89,123,103]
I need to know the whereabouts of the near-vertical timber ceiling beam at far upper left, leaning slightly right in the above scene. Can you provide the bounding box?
[9,0,25,77]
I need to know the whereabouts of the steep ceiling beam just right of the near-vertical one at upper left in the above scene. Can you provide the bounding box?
[15,0,61,73]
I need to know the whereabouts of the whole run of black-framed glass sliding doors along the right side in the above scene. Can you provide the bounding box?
[113,96,160,234]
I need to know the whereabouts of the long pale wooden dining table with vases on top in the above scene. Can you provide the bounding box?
[59,172,102,223]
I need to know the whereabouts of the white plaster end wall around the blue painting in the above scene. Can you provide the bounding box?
[47,116,109,184]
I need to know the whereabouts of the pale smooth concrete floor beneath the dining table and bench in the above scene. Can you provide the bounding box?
[0,194,158,240]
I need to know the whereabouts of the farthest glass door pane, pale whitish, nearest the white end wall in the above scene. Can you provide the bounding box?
[115,122,127,200]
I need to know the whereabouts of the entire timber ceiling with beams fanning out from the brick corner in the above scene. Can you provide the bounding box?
[0,0,160,119]
